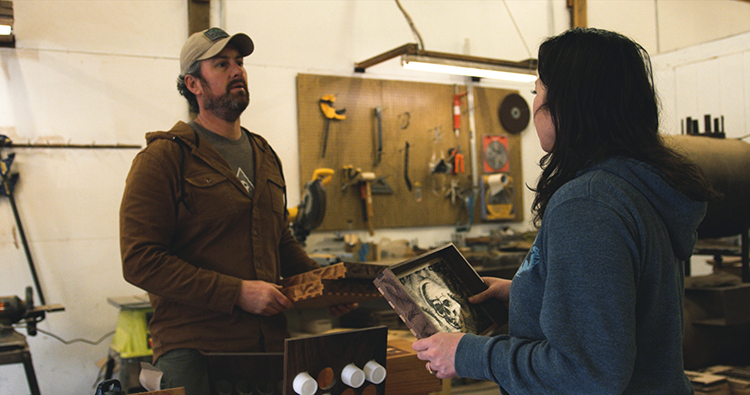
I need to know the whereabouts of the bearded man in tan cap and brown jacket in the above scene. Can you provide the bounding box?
[120,28,353,395]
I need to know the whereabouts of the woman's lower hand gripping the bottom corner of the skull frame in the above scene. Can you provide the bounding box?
[411,332,465,379]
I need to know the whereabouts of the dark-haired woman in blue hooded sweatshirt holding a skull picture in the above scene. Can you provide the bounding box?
[413,29,715,394]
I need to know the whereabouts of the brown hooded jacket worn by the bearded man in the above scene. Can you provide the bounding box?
[120,122,317,361]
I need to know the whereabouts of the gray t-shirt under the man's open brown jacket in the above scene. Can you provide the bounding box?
[188,121,255,196]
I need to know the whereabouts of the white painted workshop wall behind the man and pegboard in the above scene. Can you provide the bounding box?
[0,0,750,395]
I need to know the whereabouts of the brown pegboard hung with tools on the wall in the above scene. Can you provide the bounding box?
[297,74,524,232]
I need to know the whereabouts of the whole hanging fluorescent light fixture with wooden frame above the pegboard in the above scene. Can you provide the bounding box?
[354,44,537,82]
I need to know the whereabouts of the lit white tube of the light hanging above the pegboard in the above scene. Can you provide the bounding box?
[401,54,537,82]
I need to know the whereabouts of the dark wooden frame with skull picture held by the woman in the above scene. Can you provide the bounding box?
[374,244,508,339]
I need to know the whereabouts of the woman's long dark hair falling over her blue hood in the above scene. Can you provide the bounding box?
[532,28,716,225]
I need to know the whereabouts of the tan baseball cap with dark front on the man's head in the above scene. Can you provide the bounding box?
[180,27,255,75]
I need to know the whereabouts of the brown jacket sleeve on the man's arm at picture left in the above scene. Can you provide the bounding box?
[120,147,241,313]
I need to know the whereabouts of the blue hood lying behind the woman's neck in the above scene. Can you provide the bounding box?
[581,157,706,260]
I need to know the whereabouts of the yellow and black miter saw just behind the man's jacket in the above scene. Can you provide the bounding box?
[289,168,334,245]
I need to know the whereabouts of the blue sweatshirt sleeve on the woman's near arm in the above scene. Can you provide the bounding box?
[455,198,639,394]
